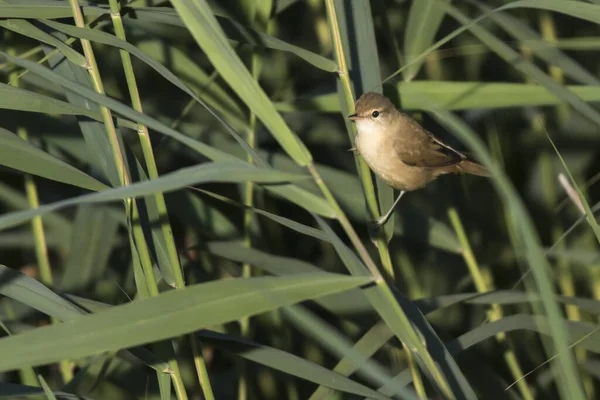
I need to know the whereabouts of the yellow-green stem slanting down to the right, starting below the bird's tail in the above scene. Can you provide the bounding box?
[448,208,534,400]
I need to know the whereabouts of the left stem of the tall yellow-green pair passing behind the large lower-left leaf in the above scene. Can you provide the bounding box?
[69,0,187,400]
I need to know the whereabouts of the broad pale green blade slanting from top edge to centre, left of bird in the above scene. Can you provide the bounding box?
[171,0,312,166]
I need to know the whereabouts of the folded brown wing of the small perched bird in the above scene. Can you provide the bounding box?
[394,121,466,168]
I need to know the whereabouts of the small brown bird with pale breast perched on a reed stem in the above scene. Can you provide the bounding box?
[348,92,489,227]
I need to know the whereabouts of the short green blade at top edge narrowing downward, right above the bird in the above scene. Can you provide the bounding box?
[404,0,448,81]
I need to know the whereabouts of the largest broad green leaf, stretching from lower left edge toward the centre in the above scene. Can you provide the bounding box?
[0,273,370,371]
